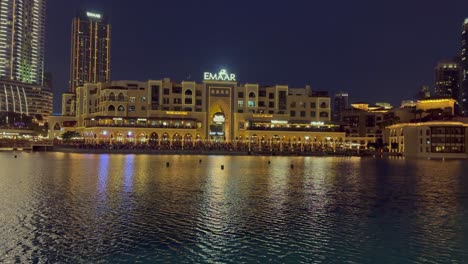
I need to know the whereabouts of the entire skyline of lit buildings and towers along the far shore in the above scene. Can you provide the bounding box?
[0,0,468,158]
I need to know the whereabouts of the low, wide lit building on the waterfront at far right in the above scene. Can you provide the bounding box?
[386,121,468,159]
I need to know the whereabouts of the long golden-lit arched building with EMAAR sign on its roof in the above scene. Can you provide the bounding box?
[50,70,345,148]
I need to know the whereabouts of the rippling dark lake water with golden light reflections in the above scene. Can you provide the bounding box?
[0,152,468,263]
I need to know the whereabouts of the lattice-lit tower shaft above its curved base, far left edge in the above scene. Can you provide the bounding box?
[0,0,46,85]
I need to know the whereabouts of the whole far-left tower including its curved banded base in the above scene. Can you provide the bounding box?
[0,0,52,118]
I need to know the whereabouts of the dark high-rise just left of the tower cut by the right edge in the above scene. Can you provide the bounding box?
[434,61,461,102]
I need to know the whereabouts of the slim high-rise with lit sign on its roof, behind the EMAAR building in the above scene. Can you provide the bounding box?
[70,12,110,93]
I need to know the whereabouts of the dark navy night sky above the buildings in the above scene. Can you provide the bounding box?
[46,0,468,112]
